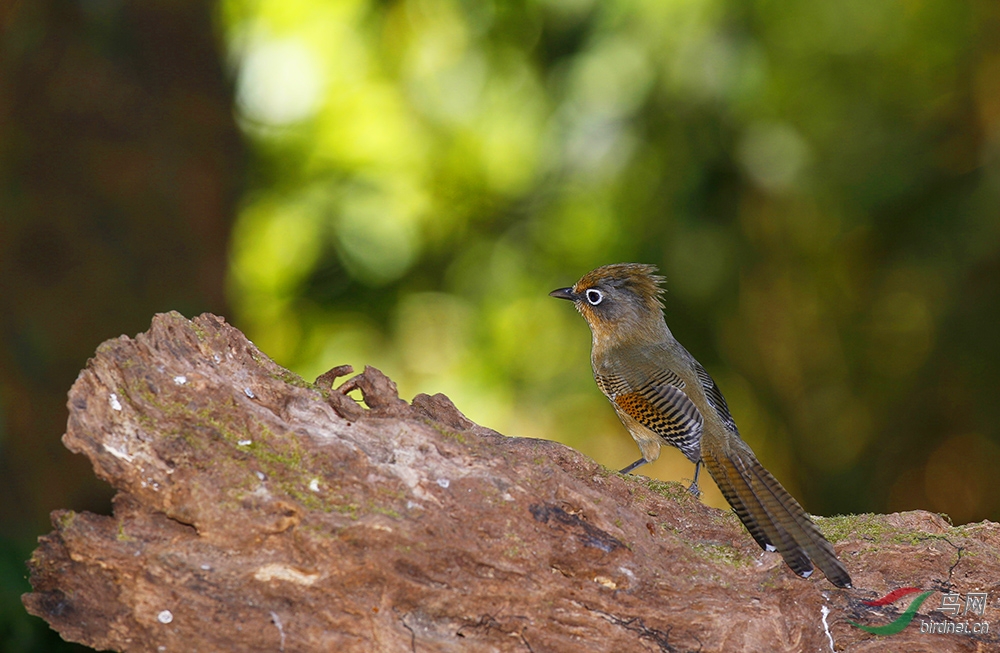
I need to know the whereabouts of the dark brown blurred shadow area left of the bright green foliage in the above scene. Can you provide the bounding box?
[0,0,245,651]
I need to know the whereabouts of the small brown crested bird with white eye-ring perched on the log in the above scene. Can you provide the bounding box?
[549,263,851,588]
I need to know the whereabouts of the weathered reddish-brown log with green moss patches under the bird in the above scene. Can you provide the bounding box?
[24,313,1000,652]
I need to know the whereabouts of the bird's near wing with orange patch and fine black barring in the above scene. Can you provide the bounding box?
[597,368,704,461]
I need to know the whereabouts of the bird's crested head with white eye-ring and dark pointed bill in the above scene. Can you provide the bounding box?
[549,263,669,344]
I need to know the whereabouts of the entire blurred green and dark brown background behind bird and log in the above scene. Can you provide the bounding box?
[0,0,1000,651]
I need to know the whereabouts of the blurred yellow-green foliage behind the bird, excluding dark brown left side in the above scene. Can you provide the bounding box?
[219,0,1000,522]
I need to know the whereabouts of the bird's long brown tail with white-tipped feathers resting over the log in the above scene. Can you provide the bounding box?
[702,441,851,587]
